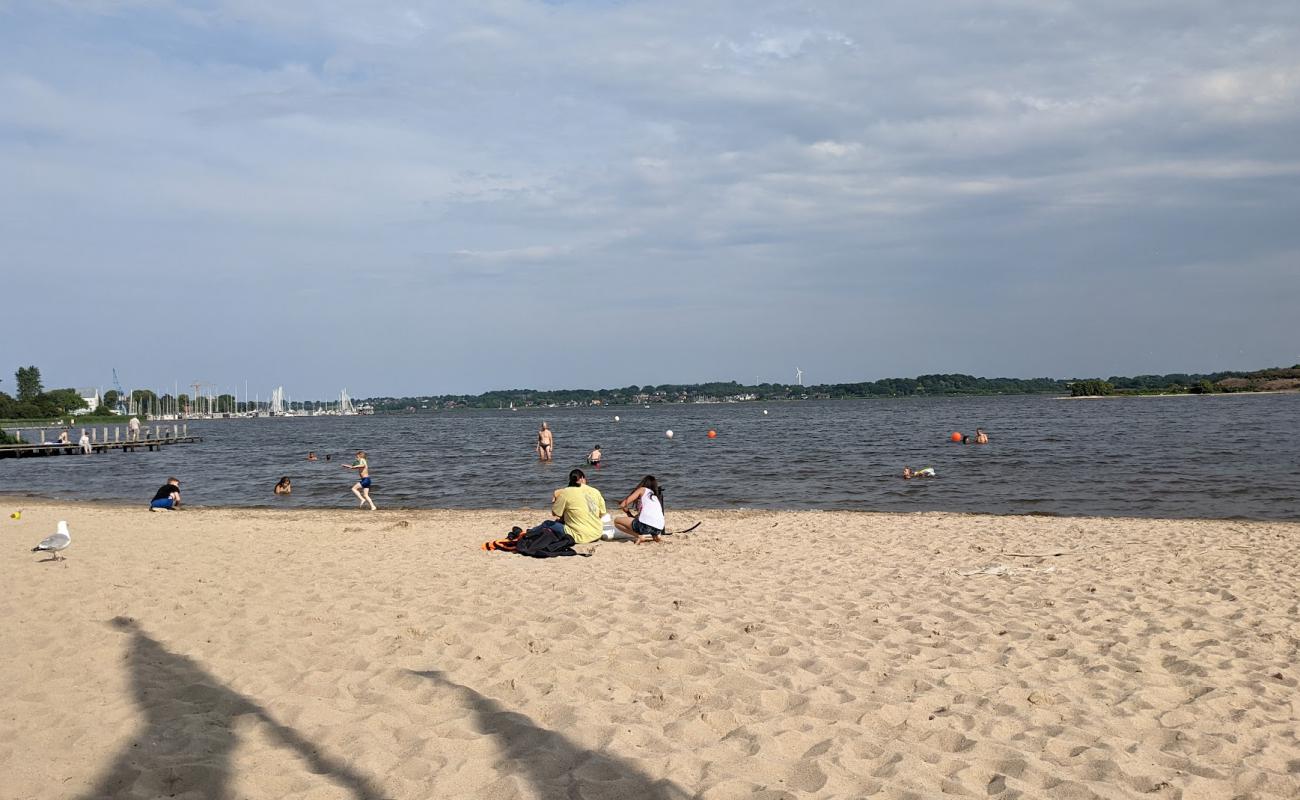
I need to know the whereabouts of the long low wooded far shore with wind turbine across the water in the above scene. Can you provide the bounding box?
[364,364,1300,411]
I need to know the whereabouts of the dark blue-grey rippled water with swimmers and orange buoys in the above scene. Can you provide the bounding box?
[0,394,1300,519]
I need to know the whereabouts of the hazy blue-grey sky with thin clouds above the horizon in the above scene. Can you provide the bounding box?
[0,0,1300,399]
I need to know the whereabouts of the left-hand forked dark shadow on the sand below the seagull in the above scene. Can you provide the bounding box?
[83,617,382,800]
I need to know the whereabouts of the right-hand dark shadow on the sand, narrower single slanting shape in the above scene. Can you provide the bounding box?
[413,670,692,800]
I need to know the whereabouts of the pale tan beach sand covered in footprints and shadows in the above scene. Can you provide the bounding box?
[0,500,1300,800]
